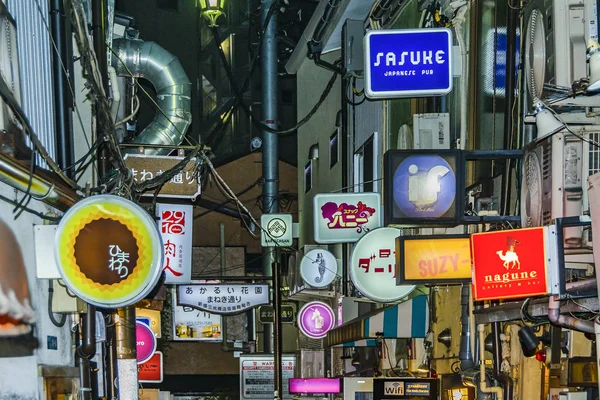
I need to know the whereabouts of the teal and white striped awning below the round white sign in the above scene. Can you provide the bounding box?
[325,295,429,347]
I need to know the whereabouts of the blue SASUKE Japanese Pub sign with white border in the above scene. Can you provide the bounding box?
[364,28,452,99]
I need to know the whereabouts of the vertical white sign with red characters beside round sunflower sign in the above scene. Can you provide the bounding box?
[156,203,194,283]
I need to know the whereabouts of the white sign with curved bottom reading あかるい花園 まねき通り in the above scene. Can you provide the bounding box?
[177,284,269,315]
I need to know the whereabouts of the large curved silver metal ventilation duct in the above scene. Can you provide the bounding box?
[112,39,192,155]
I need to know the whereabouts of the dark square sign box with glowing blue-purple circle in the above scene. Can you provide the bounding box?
[383,150,464,225]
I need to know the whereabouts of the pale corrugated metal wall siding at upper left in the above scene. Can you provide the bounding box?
[6,0,56,168]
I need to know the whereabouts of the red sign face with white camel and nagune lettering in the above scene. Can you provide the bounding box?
[471,227,548,300]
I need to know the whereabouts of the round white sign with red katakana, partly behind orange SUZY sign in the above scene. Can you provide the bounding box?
[350,228,416,303]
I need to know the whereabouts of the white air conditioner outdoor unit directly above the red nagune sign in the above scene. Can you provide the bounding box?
[521,131,585,244]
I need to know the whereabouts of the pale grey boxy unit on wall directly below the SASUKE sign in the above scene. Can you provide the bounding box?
[413,113,450,149]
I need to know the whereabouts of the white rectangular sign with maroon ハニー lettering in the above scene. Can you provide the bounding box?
[313,193,383,243]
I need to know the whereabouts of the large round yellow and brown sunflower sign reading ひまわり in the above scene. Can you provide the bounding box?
[55,195,163,308]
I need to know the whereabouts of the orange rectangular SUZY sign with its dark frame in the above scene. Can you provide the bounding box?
[396,235,471,285]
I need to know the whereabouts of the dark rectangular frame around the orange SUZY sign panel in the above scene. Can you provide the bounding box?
[396,234,472,285]
